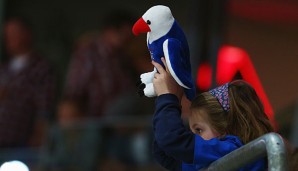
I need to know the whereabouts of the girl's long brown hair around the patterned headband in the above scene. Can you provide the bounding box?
[191,80,273,144]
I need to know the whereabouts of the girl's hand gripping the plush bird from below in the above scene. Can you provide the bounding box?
[152,58,183,101]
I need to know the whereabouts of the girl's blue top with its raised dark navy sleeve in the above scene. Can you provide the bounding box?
[153,94,266,171]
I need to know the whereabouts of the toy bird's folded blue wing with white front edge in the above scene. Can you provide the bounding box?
[163,38,195,100]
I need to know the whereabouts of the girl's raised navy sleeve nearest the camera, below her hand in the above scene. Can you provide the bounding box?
[153,94,195,163]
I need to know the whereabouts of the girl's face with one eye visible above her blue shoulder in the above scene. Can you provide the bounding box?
[189,109,220,140]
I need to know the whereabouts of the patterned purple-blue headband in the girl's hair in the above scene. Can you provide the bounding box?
[209,83,230,112]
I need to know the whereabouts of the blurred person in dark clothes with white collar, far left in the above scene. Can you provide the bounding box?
[0,17,54,147]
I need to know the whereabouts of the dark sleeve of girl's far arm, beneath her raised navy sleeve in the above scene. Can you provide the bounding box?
[153,140,182,171]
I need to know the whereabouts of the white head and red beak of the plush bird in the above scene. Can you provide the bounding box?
[132,5,174,42]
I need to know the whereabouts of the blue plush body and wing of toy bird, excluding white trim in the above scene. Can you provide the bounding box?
[147,21,195,100]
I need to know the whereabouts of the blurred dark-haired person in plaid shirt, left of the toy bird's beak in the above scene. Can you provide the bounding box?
[65,11,139,117]
